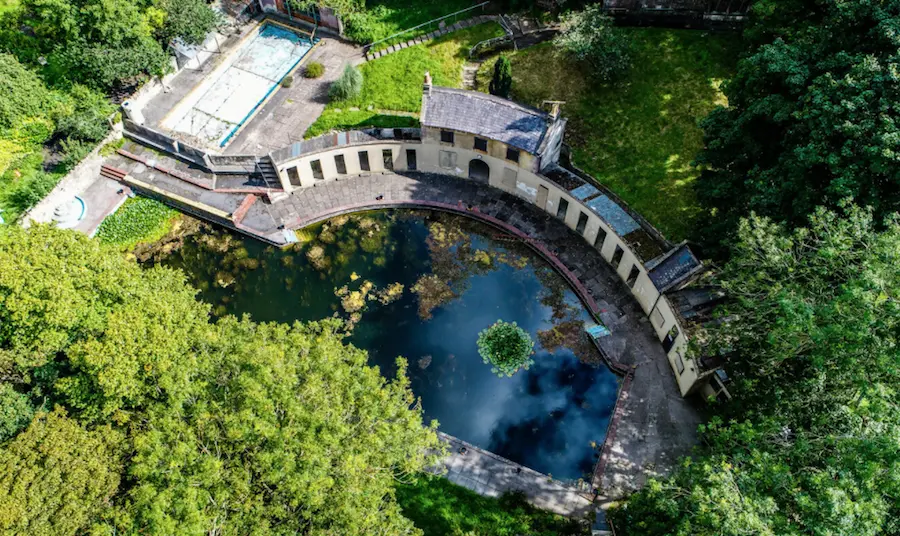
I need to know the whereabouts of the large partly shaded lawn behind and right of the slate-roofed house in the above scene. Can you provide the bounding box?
[478,28,738,241]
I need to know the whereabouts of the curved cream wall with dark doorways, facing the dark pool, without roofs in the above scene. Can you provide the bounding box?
[271,133,712,396]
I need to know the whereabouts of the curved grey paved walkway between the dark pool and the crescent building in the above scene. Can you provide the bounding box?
[100,156,701,498]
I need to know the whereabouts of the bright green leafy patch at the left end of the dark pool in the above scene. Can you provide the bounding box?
[96,197,179,251]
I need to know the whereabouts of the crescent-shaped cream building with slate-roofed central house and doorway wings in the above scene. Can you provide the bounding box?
[269,77,715,395]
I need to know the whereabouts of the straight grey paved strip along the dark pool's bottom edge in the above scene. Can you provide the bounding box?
[438,433,594,518]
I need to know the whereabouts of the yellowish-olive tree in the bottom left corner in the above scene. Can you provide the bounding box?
[0,409,123,536]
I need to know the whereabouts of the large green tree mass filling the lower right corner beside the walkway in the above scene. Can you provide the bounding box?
[613,206,900,536]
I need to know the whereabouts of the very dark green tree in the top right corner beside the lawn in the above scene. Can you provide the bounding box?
[697,0,900,251]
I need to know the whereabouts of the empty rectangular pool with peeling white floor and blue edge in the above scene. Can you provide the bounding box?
[162,23,313,147]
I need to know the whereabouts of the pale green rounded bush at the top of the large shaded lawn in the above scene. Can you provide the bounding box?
[555,4,630,82]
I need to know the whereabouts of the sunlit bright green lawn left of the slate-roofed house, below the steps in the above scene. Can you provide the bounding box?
[306,22,503,137]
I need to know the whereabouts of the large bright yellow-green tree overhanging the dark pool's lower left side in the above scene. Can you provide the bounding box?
[120,317,437,536]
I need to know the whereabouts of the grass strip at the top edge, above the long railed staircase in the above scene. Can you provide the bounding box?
[344,0,482,50]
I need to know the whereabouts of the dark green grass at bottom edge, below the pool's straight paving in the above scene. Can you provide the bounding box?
[397,477,589,536]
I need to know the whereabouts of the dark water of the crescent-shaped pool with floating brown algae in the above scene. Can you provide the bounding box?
[156,211,618,479]
